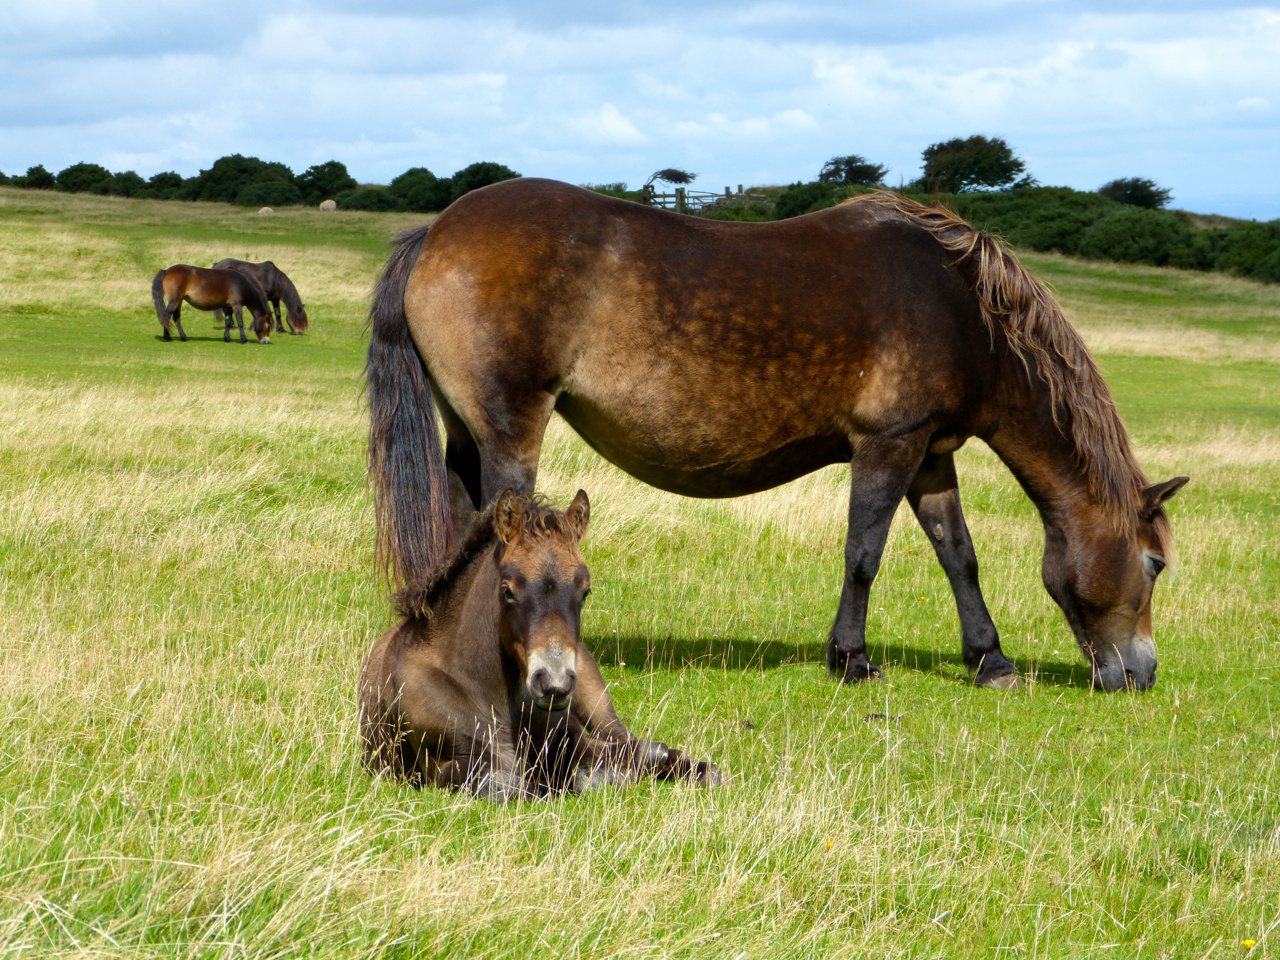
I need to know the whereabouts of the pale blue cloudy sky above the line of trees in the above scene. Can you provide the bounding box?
[0,0,1280,220]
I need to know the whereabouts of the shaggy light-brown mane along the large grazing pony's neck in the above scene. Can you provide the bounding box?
[849,191,1171,548]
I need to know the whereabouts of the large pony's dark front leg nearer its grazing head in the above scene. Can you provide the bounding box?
[906,453,1018,689]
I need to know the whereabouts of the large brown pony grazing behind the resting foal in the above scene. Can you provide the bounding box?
[366,179,1185,690]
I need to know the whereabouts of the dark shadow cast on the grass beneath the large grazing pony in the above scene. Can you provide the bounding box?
[584,635,1089,690]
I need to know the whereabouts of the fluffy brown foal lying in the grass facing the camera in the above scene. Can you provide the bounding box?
[358,490,719,800]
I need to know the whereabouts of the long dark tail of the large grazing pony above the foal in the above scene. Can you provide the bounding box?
[365,227,453,588]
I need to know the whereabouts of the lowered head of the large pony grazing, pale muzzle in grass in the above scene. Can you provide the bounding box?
[1042,476,1187,690]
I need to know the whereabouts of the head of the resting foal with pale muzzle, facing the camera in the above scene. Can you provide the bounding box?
[494,490,591,710]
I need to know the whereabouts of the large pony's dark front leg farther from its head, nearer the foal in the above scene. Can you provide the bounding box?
[827,431,928,684]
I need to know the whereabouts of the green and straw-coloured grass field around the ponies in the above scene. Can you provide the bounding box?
[0,188,1280,959]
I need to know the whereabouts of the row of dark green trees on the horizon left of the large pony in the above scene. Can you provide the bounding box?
[0,154,520,212]
